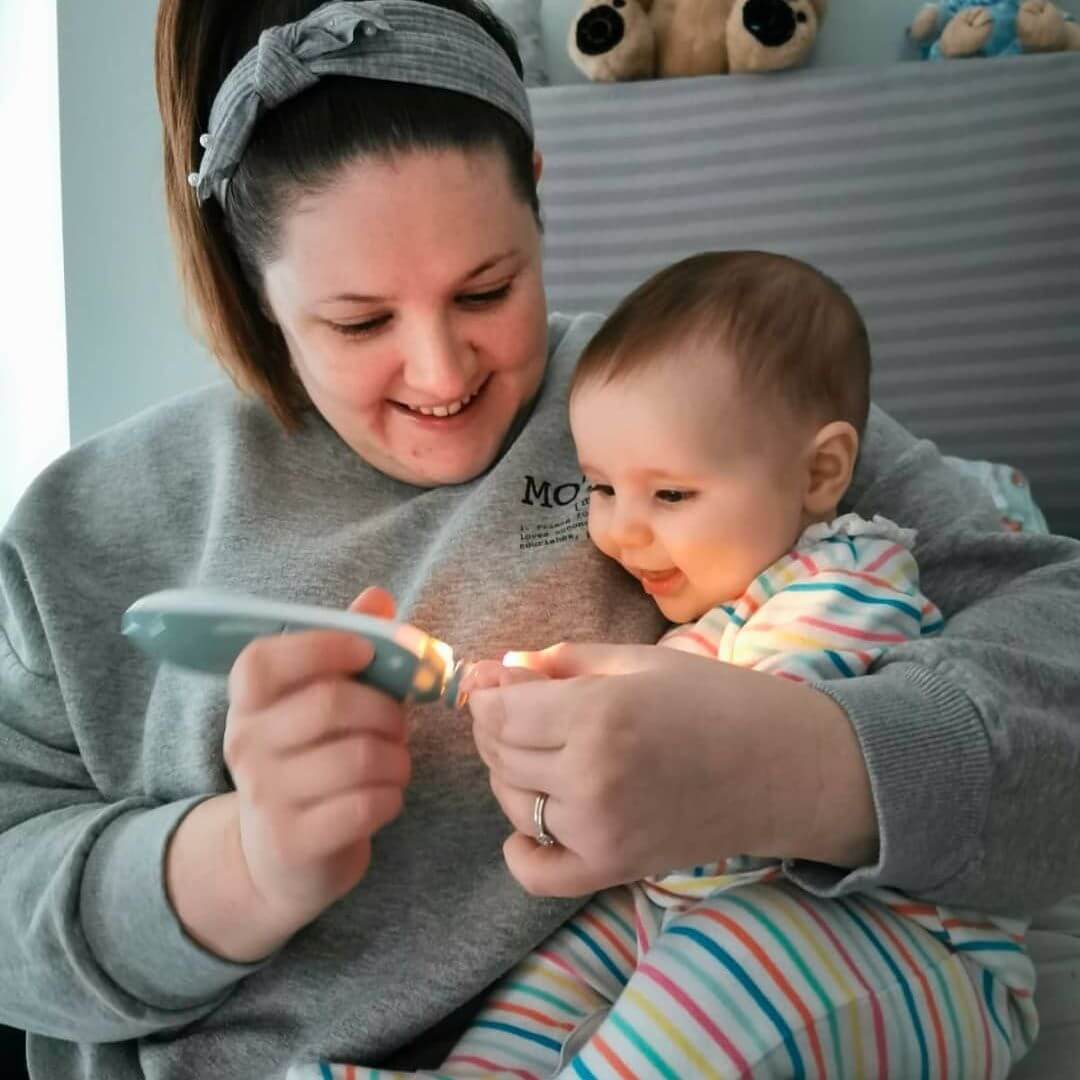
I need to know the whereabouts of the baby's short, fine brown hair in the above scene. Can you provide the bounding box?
[570,252,870,437]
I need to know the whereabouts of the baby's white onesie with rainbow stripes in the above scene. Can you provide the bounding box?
[288,514,1038,1080]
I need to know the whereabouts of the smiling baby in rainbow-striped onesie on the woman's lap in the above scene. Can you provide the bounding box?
[302,252,1037,1080]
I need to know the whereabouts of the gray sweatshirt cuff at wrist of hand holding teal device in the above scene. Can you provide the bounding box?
[80,796,267,1011]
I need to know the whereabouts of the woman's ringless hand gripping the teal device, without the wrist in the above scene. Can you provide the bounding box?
[225,590,409,926]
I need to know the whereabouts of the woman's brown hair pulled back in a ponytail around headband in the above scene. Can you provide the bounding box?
[154,0,539,429]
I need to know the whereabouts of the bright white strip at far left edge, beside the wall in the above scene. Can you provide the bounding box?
[0,0,68,525]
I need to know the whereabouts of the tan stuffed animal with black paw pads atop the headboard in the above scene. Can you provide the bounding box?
[567,0,827,82]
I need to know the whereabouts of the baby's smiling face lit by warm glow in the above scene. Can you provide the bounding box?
[570,359,807,622]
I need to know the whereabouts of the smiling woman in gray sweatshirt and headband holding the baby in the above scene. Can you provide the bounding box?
[0,0,1080,1080]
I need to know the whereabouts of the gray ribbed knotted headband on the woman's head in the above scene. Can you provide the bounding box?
[188,0,532,207]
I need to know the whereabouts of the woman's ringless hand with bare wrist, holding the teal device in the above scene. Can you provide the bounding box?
[166,590,410,960]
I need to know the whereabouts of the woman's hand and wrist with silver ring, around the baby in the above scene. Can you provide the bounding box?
[470,645,877,895]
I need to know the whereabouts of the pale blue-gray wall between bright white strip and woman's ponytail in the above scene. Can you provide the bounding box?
[57,0,220,443]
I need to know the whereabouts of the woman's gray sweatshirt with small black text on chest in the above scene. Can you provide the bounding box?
[0,316,1080,1080]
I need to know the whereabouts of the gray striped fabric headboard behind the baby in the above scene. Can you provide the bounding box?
[530,53,1080,537]
